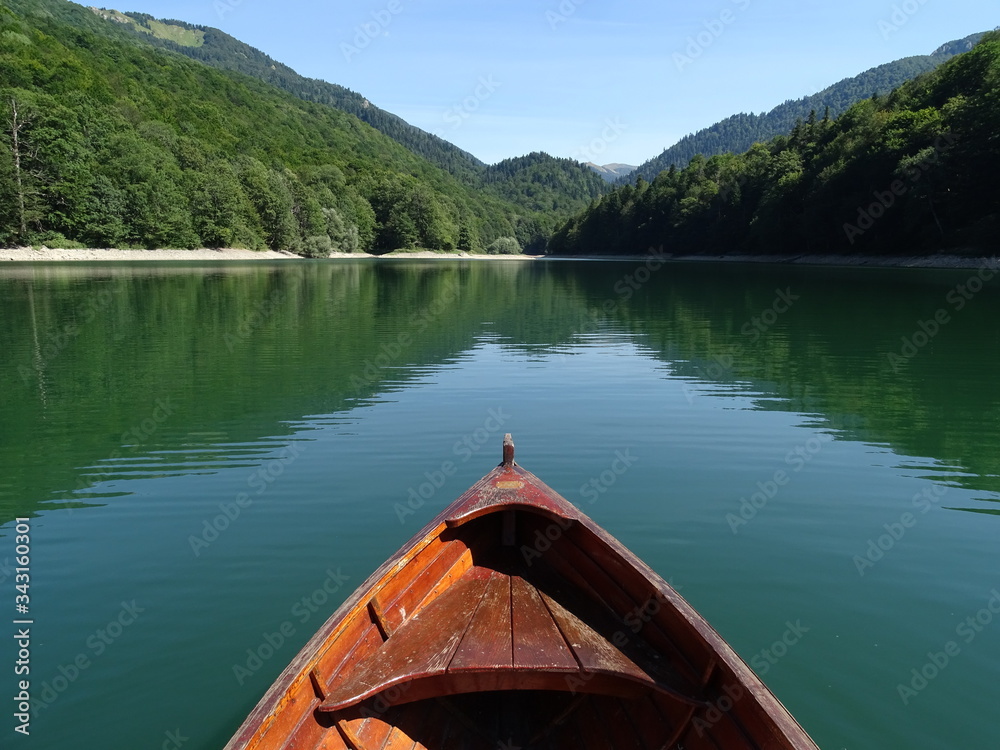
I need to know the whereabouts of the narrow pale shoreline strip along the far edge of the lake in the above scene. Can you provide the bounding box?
[0,247,1000,268]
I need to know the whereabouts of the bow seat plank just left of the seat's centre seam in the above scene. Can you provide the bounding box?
[448,573,513,674]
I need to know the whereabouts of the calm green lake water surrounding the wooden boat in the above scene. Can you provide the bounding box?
[0,260,1000,750]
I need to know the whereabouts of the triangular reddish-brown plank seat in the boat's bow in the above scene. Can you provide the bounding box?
[318,567,708,713]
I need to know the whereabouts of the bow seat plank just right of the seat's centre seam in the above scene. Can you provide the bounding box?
[510,576,580,672]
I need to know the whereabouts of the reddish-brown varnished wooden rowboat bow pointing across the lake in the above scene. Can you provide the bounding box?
[226,435,816,750]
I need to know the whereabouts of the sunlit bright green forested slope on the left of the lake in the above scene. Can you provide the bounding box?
[0,0,600,255]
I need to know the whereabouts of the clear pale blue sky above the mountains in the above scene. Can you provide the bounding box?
[111,0,1000,164]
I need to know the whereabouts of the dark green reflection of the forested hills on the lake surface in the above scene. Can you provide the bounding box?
[0,261,1000,521]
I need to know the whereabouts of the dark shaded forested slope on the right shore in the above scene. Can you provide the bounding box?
[549,32,1000,255]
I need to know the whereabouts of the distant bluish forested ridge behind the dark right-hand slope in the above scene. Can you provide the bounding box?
[617,34,983,185]
